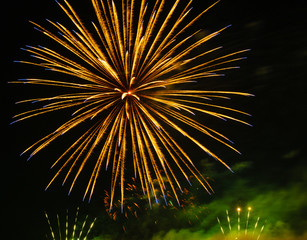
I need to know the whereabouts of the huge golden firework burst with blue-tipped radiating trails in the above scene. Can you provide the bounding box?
[13,0,251,209]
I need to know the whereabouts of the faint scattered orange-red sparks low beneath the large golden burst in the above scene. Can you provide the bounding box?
[104,178,207,232]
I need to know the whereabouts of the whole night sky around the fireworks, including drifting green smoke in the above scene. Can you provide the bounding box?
[1,0,307,240]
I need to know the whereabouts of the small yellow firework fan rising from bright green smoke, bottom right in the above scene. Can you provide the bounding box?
[217,207,264,240]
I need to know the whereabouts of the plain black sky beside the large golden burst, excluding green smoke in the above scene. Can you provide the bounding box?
[1,0,307,239]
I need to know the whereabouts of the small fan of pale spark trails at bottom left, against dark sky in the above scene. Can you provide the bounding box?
[45,208,96,240]
